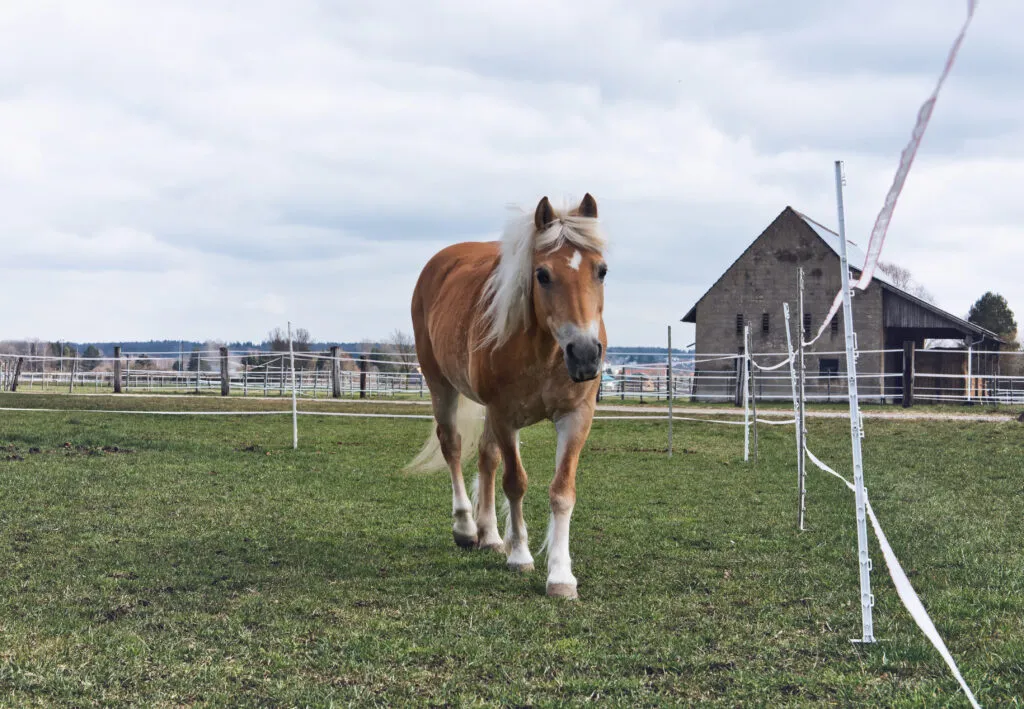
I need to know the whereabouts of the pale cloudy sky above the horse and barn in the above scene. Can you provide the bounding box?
[0,0,1024,345]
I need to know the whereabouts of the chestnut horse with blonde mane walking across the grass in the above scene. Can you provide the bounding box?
[406,193,608,598]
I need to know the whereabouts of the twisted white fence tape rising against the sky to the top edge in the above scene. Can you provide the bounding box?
[804,0,978,347]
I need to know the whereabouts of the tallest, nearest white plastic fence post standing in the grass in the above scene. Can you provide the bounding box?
[836,160,874,642]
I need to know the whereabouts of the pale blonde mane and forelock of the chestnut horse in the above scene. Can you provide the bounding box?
[480,199,606,346]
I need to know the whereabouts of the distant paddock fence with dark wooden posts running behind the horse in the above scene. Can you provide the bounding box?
[0,349,1024,406]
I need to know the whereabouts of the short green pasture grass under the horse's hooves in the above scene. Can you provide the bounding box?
[0,394,1024,707]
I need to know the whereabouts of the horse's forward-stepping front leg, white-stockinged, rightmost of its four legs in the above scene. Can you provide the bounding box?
[546,409,594,598]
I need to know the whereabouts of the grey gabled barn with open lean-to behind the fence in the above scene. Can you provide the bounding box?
[682,206,1002,402]
